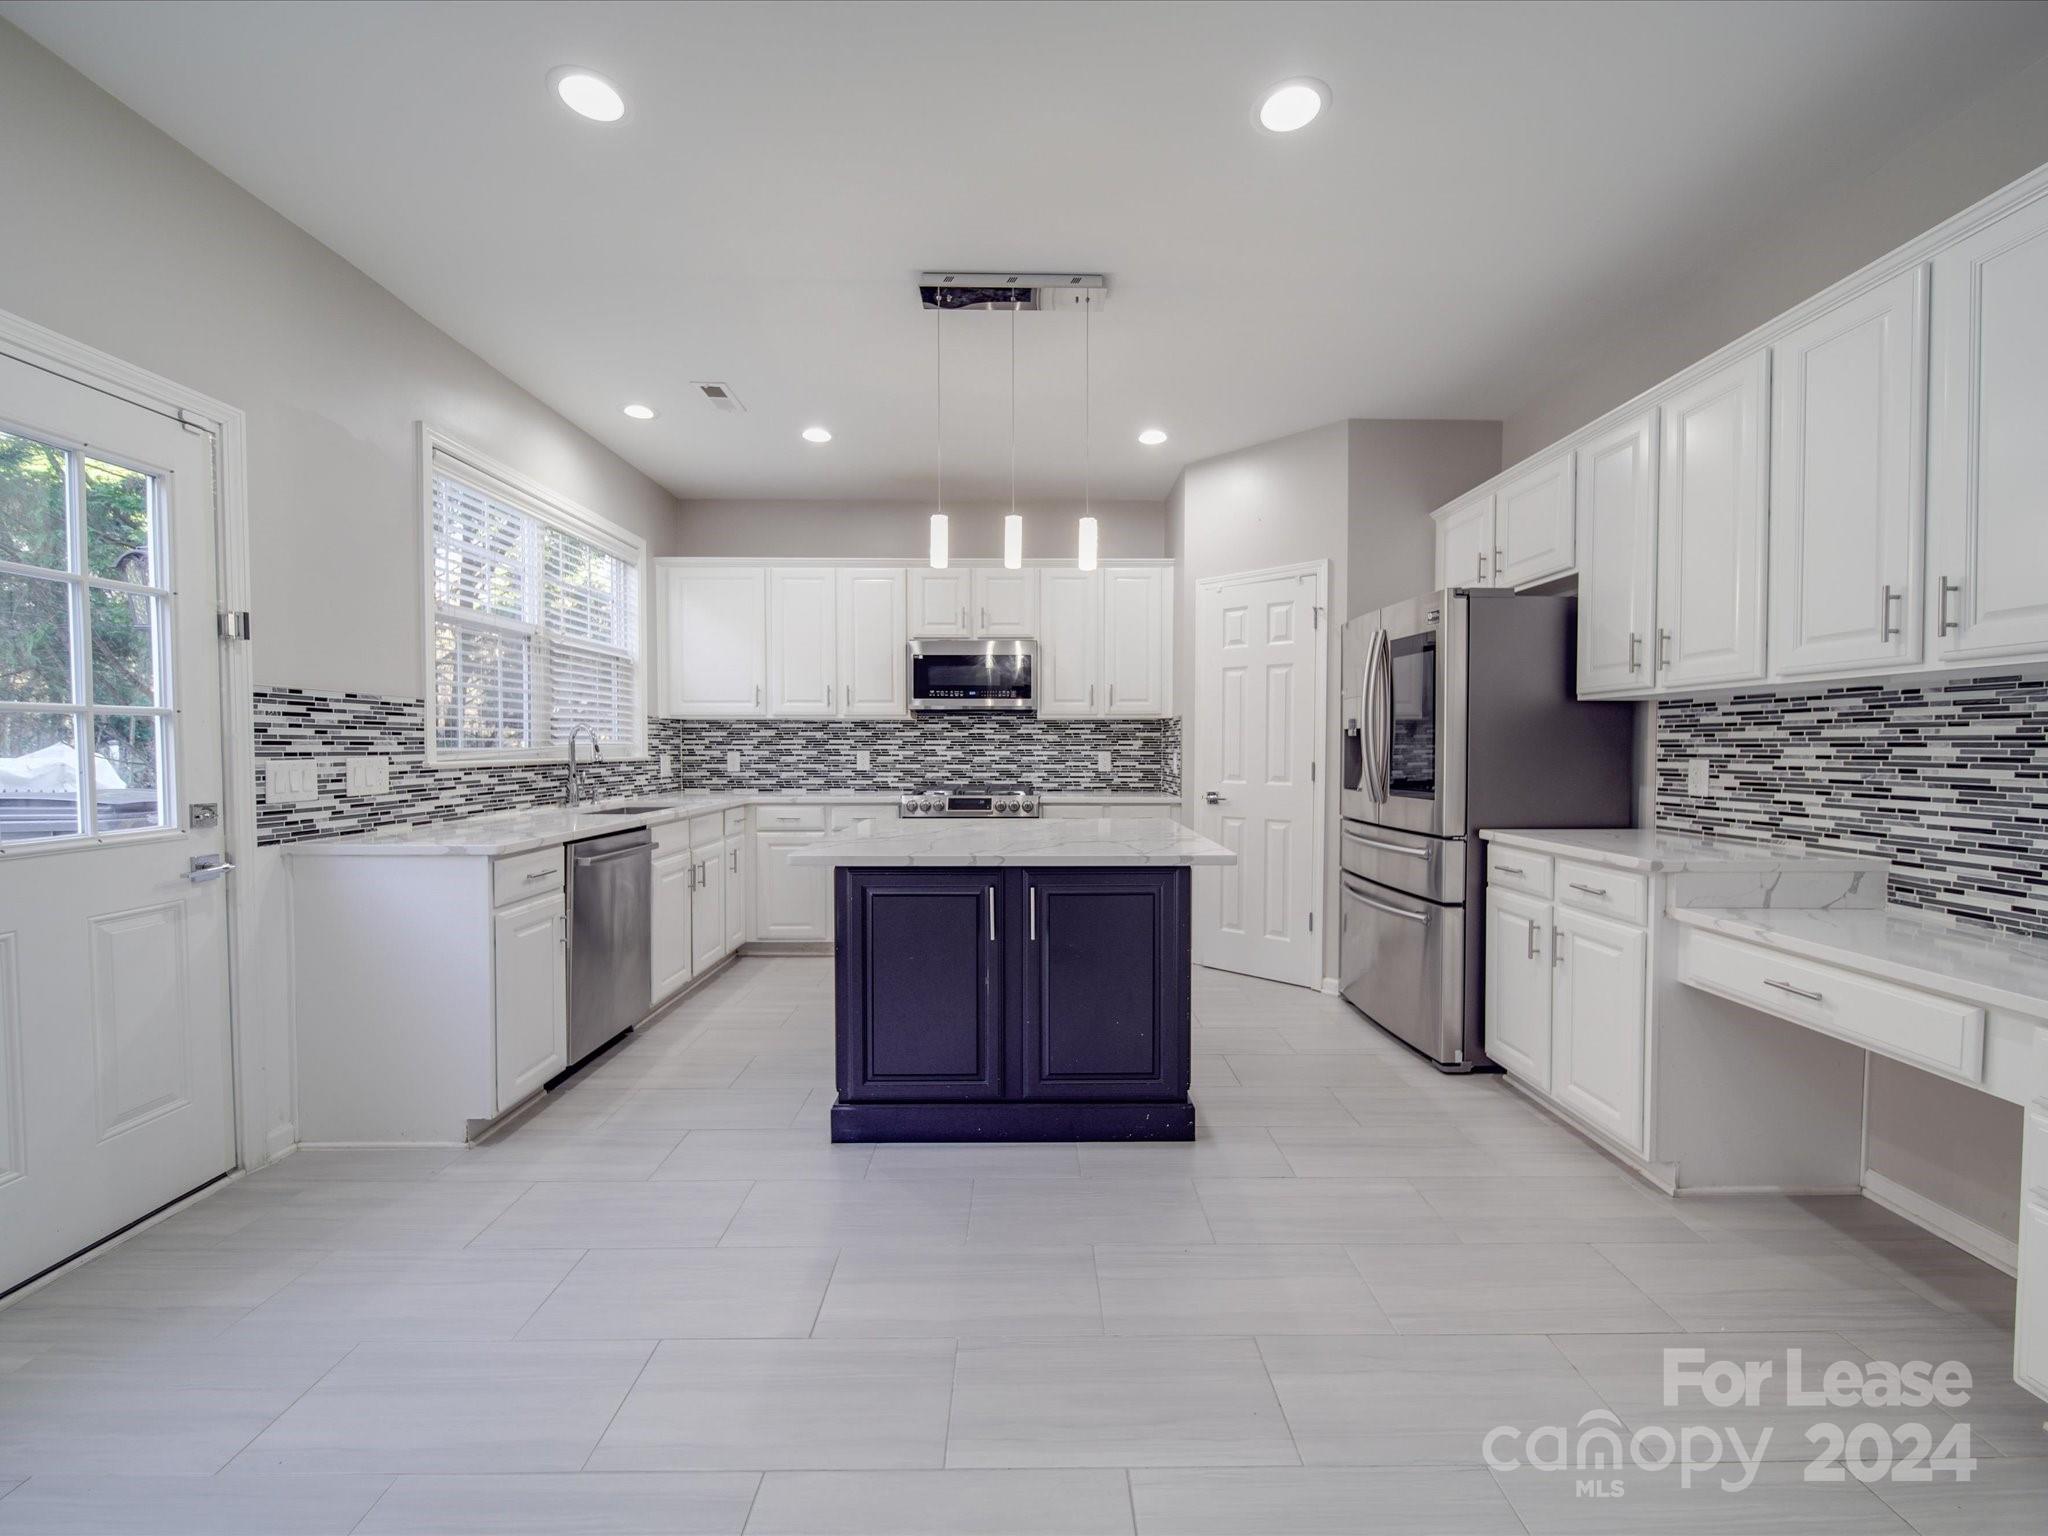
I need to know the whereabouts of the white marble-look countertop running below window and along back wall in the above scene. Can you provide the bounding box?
[281,788,1180,858]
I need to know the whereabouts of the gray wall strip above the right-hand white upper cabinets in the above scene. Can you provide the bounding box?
[1501,59,2048,465]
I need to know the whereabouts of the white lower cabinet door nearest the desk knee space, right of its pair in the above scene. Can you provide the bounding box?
[1550,907,1649,1151]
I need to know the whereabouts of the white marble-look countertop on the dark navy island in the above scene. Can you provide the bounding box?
[788,815,1237,866]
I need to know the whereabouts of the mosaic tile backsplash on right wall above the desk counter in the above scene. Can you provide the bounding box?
[1657,676,2048,938]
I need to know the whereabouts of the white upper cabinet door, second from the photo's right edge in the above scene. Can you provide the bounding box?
[1769,266,1925,676]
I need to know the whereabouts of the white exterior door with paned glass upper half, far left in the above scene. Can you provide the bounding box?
[0,356,236,1290]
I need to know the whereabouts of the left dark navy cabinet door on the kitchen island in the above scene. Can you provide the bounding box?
[838,868,1004,1104]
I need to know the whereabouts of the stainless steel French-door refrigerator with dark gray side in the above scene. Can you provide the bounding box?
[1337,588,1634,1071]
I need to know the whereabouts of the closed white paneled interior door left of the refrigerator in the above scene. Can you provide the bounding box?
[1190,573,1323,987]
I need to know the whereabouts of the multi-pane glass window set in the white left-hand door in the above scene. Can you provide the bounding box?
[0,428,174,842]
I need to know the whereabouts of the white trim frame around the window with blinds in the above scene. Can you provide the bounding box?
[416,422,653,768]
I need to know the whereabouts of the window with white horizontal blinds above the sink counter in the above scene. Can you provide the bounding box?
[426,434,647,762]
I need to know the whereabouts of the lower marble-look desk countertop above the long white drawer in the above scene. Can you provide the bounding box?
[1671,907,2048,1020]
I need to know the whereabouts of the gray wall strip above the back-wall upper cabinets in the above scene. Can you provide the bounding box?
[670,500,1165,559]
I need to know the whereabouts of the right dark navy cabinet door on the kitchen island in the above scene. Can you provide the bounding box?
[1014,868,1190,1100]
